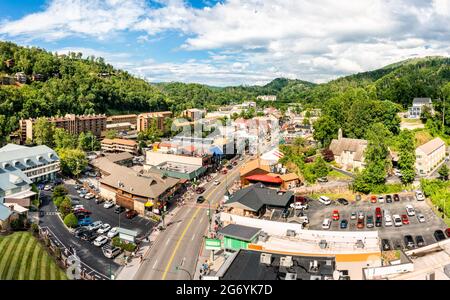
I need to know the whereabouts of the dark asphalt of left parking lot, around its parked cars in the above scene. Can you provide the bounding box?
[39,180,155,277]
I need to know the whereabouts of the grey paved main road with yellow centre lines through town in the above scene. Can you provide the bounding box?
[134,161,243,280]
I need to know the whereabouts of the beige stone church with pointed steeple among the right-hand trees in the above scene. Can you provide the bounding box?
[329,129,368,170]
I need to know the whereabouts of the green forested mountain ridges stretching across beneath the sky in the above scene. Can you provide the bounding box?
[0,42,450,141]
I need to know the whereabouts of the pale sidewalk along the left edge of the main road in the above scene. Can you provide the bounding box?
[115,206,182,280]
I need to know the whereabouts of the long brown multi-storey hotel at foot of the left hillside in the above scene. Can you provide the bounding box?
[19,114,106,143]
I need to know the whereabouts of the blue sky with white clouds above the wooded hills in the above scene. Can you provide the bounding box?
[0,0,450,86]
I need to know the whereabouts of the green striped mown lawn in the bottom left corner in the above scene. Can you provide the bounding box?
[0,232,67,280]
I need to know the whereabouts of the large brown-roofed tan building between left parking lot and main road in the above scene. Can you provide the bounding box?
[90,157,180,215]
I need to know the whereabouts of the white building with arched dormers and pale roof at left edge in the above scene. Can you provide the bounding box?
[0,144,60,182]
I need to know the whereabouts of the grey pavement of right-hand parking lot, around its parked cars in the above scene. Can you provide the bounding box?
[305,193,447,248]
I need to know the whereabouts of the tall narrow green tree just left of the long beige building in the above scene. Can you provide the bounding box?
[398,129,416,184]
